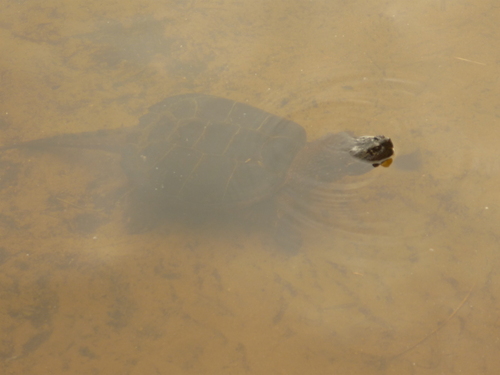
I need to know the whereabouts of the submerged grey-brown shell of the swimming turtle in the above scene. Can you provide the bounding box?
[123,94,306,207]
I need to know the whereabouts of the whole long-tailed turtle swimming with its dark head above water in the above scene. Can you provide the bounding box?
[0,93,394,249]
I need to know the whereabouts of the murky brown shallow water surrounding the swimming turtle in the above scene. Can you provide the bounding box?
[0,0,500,374]
